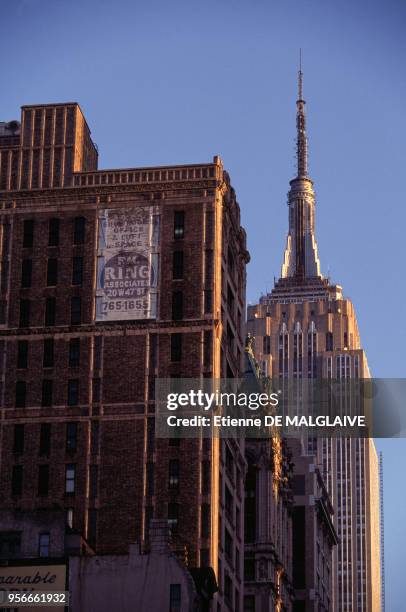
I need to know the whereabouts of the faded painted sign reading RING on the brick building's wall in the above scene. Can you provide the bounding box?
[96,206,159,321]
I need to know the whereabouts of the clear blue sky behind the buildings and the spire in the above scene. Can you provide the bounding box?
[0,0,406,612]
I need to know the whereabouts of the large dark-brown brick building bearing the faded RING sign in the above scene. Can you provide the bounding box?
[0,104,249,610]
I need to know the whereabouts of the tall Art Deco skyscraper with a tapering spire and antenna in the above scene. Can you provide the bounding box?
[248,70,380,612]
